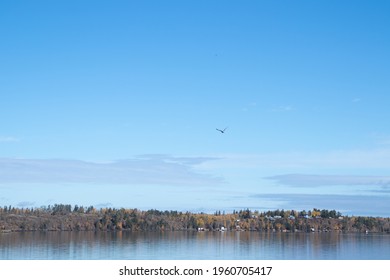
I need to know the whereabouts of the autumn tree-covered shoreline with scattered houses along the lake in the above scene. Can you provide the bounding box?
[0,204,390,233]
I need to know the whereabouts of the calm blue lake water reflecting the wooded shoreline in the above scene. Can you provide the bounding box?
[0,232,390,260]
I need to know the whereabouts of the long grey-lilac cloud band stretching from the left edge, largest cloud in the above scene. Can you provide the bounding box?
[0,155,222,185]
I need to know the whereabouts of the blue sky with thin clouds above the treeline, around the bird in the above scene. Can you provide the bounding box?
[0,1,390,216]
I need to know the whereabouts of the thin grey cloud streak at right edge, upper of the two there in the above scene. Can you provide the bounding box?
[265,174,390,187]
